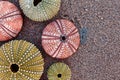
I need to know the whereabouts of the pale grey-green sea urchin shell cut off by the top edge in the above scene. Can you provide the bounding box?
[19,0,61,21]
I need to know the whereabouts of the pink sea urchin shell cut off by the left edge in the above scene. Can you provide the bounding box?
[0,1,23,41]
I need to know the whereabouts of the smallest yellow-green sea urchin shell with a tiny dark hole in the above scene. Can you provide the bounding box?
[47,62,71,80]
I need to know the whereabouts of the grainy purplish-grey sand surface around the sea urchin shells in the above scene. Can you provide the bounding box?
[0,0,120,80]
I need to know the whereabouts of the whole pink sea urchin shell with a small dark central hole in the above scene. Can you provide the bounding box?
[42,19,80,59]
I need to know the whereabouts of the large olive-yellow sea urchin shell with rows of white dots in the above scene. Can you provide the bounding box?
[0,40,44,80]
